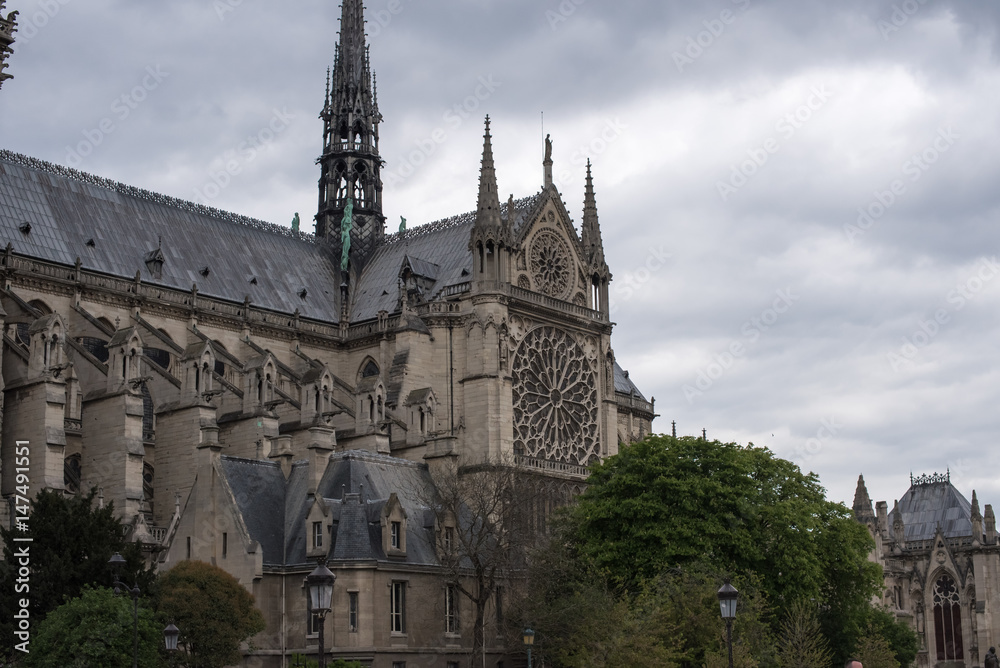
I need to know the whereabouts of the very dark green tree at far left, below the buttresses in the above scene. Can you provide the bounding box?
[0,489,155,657]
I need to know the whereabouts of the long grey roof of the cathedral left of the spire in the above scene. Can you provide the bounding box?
[0,151,342,322]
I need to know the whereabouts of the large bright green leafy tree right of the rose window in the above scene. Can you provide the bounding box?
[568,436,881,655]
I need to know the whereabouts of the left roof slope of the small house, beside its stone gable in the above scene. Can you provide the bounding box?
[220,456,286,564]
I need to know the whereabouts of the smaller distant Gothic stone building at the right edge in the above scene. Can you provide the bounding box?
[854,473,1000,668]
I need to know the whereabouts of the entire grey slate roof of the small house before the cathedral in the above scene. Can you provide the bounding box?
[220,450,437,566]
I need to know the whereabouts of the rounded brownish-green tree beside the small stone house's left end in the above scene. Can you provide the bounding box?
[158,561,265,668]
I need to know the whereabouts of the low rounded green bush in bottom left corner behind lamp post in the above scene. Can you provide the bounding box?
[22,587,163,668]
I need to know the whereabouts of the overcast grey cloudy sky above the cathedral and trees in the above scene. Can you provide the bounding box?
[0,0,1000,506]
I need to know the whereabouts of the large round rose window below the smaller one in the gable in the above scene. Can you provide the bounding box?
[512,327,600,466]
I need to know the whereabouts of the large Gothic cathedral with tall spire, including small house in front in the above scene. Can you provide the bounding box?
[0,0,654,668]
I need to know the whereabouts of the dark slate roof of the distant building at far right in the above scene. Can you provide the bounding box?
[899,481,972,540]
